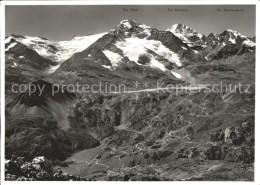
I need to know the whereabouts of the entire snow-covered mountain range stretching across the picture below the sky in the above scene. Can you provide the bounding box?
[5,20,255,85]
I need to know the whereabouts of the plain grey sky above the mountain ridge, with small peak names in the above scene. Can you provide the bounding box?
[6,5,256,40]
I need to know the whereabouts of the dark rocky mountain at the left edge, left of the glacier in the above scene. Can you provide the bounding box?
[5,37,57,89]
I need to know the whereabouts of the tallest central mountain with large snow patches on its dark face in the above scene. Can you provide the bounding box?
[50,20,207,84]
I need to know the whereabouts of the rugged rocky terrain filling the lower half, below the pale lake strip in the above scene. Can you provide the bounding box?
[5,88,255,181]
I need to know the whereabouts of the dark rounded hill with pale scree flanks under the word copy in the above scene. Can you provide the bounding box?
[6,80,76,129]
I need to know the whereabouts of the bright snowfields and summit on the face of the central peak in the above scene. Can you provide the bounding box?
[110,20,183,68]
